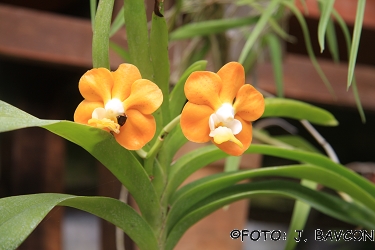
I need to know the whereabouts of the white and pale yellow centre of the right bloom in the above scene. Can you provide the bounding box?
[208,103,243,148]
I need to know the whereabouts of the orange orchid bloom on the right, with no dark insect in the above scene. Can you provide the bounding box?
[181,62,264,156]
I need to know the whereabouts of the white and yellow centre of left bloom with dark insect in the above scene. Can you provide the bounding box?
[88,98,126,134]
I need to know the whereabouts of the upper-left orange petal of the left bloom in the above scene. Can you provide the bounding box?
[78,68,113,103]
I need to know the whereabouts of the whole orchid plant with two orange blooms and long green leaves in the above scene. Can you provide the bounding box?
[0,0,375,250]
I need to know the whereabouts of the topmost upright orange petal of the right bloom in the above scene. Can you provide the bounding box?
[217,62,245,104]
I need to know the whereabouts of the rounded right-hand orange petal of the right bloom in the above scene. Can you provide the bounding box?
[233,84,264,121]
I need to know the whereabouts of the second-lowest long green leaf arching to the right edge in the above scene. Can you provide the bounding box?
[167,164,375,232]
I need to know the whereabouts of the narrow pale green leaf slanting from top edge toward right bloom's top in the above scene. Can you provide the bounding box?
[238,0,280,64]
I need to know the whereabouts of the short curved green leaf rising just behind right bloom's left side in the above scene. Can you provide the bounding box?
[169,60,207,118]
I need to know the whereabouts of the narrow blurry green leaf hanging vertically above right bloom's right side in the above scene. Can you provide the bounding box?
[264,34,284,97]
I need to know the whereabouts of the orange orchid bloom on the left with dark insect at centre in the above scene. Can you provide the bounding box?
[74,63,163,150]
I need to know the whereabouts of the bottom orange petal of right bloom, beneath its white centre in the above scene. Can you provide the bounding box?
[211,115,253,156]
